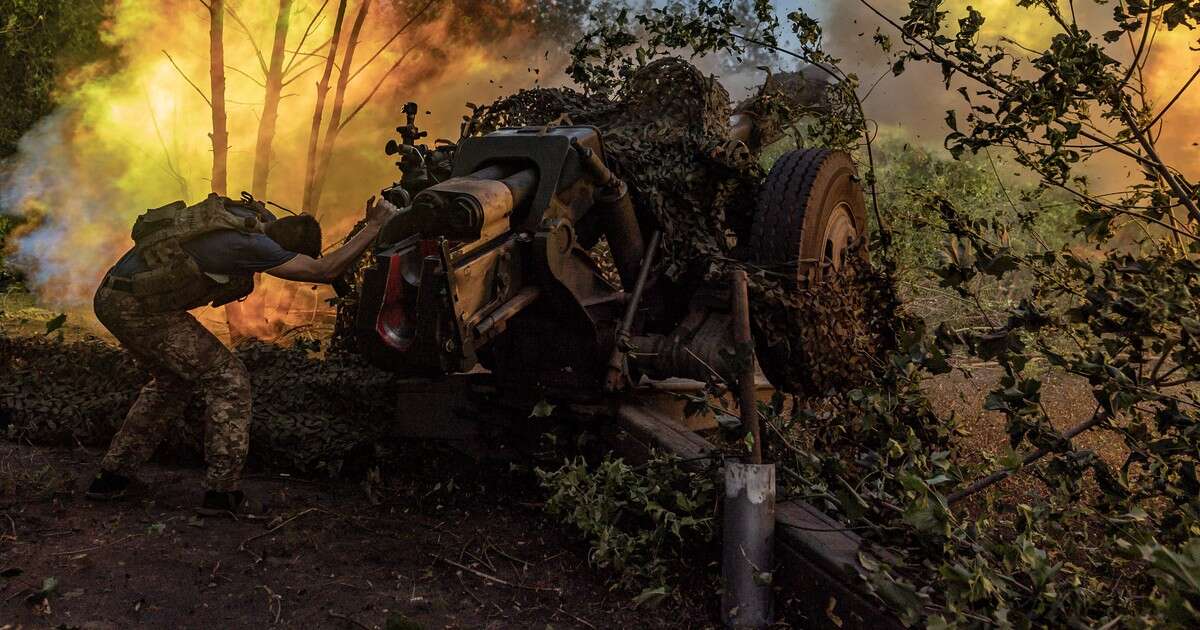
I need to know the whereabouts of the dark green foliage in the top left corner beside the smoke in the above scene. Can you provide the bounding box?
[0,0,112,157]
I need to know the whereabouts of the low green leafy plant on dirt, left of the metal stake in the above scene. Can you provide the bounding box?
[538,454,714,600]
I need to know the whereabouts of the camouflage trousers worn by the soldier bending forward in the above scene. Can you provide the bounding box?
[95,287,251,491]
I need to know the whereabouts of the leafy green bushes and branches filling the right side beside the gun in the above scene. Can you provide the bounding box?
[604,0,1200,628]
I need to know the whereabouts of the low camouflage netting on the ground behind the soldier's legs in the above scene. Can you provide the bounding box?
[0,336,396,470]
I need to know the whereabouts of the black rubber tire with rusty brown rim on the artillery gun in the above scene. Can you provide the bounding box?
[750,149,866,283]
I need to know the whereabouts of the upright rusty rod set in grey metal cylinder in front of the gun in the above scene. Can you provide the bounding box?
[721,270,775,629]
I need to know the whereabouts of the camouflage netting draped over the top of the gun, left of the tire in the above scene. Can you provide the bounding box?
[464,58,764,280]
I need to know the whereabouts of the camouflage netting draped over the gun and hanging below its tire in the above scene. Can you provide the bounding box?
[463,58,898,395]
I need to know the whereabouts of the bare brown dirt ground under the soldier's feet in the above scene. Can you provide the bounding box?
[0,444,716,630]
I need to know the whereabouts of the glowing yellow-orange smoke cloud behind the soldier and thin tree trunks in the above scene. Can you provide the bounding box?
[0,0,571,308]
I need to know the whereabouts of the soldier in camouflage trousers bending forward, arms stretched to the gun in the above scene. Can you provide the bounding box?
[86,194,398,516]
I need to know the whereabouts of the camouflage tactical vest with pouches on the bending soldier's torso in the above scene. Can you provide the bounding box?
[120,193,270,312]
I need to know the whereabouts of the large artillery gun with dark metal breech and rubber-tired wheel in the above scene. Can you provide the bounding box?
[343,65,866,400]
